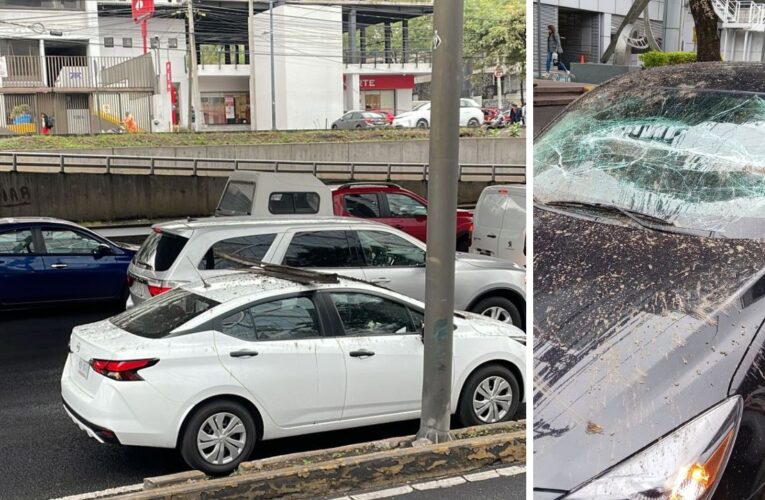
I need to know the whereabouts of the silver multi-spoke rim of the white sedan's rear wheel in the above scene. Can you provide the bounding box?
[197,412,247,465]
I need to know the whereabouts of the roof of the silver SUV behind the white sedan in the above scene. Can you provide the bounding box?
[154,215,388,232]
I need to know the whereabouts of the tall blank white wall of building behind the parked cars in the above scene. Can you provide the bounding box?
[254,5,344,130]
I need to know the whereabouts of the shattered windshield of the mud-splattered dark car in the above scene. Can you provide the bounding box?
[534,87,765,239]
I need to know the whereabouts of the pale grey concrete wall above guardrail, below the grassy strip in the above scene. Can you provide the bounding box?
[38,137,526,165]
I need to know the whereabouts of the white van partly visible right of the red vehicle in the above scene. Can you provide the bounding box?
[470,185,526,267]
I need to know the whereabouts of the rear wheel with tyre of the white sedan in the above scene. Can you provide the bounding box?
[180,400,257,476]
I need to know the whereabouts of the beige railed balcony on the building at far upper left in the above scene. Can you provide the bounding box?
[0,54,157,94]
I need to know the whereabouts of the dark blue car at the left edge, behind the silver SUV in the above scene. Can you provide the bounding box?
[0,217,134,309]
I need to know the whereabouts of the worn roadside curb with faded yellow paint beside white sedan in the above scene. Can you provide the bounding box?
[109,420,526,500]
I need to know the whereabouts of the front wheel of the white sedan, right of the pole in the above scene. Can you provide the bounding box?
[457,365,521,426]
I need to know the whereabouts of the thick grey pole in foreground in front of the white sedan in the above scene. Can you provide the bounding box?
[417,0,464,443]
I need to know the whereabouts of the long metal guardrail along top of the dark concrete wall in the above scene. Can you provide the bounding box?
[0,151,526,184]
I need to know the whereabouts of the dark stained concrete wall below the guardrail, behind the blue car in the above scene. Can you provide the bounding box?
[0,172,496,222]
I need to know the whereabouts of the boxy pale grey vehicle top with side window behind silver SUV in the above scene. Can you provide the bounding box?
[215,171,334,217]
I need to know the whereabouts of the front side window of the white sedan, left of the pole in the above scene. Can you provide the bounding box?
[330,292,415,337]
